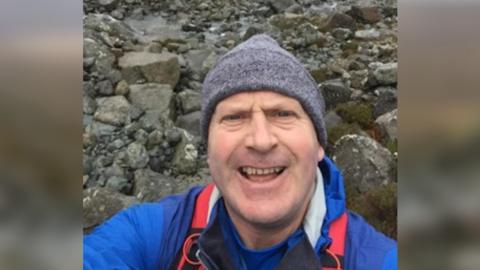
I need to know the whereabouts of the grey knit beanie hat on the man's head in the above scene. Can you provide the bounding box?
[201,34,327,148]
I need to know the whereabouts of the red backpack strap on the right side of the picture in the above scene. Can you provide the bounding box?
[322,212,348,270]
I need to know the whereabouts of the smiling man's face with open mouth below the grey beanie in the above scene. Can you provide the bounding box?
[208,91,324,230]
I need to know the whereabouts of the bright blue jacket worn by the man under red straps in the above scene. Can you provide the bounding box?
[83,157,397,270]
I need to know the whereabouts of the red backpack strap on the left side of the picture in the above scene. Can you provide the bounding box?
[174,183,215,270]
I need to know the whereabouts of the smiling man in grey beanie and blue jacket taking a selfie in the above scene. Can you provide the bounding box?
[84,35,397,270]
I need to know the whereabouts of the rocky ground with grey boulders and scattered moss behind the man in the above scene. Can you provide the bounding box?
[83,0,398,237]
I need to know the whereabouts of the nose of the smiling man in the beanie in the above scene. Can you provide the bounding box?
[245,112,278,153]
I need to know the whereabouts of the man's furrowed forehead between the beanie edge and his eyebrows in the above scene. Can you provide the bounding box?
[216,91,303,110]
